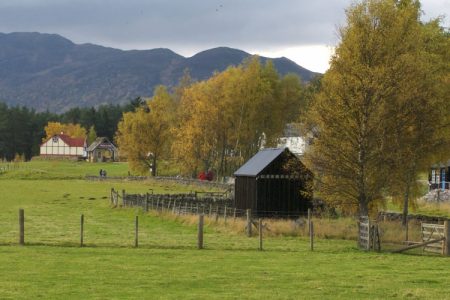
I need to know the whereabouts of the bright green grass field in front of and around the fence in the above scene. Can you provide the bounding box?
[0,162,450,299]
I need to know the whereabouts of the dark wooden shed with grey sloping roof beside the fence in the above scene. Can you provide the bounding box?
[234,148,313,217]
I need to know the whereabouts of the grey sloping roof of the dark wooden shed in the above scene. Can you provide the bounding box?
[234,148,289,176]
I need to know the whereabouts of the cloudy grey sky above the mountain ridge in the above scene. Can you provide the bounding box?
[0,0,450,72]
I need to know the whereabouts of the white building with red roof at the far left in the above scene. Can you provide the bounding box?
[40,133,86,158]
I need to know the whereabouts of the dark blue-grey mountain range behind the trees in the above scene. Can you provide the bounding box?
[0,32,316,112]
